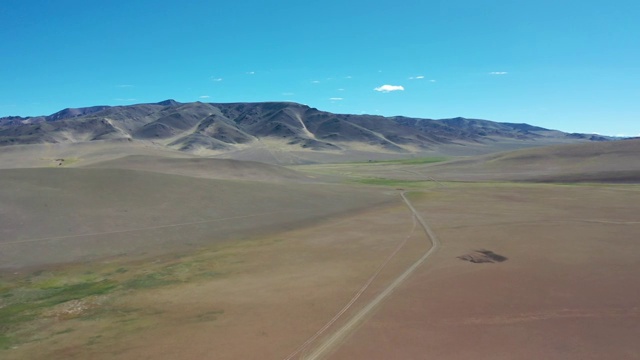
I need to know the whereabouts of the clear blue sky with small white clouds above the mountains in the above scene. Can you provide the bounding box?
[0,0,640,135]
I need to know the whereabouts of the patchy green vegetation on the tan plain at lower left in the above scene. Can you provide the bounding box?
[0,240,260,350]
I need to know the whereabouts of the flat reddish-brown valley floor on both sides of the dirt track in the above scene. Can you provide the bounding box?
[3,183,640,359]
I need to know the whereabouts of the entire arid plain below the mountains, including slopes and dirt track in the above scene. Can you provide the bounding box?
[0,140,640,359]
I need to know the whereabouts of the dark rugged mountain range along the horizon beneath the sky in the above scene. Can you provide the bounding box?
[0,100,612,154]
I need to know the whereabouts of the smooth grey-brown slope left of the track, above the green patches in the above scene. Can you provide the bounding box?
[0,168,391,268]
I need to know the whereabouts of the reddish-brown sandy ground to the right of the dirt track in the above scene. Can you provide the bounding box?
[329,185,640,359]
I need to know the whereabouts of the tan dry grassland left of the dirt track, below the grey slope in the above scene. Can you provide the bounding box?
[3,201,428,359]
